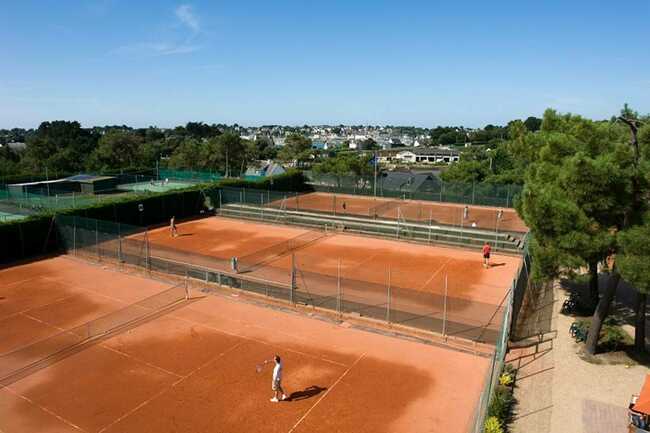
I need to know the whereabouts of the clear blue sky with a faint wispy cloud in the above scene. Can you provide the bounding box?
[0,0,650,128]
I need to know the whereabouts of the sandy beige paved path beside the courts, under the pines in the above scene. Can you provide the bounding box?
[509,285,650,433]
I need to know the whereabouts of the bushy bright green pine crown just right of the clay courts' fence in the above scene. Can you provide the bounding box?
[514,110,633,278]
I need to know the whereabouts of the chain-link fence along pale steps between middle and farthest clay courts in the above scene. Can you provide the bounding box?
[211,187,525,254]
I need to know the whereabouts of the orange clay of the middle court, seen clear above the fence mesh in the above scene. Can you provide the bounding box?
[149,217,521,305]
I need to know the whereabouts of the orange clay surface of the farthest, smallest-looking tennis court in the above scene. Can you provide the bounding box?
[269,192,528,233]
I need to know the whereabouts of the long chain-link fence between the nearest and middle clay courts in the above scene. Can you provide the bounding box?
[56,216,506,344]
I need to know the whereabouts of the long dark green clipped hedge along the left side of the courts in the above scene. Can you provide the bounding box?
[0,170,307,263]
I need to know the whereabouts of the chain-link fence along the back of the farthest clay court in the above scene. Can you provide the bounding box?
[306,172,522,208]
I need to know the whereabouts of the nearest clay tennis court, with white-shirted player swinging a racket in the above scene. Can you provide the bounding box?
[0,256,490,433]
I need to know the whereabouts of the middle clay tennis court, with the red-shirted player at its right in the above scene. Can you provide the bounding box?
[148,217,521,342]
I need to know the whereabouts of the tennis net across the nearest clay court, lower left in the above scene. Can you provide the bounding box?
[0,282,188,386]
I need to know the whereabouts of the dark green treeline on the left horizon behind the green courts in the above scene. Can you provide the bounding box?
[0,121,277,176]
